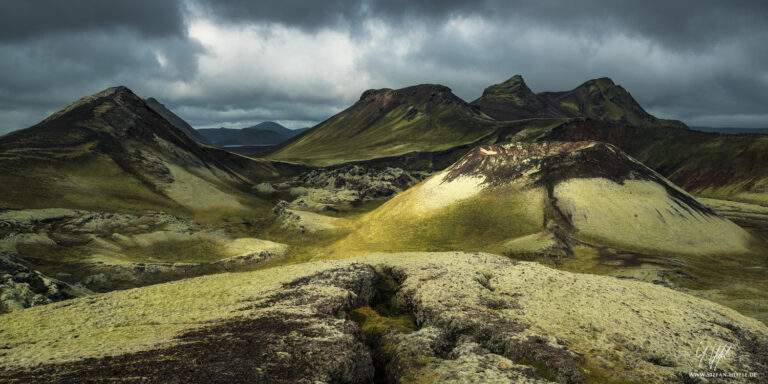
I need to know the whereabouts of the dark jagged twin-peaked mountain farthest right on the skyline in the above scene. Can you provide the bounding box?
[472,75,685,128]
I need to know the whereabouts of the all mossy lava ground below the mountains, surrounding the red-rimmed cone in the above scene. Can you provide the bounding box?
[0,168,768,383]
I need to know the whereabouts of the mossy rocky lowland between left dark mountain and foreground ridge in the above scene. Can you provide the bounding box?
[0,209,287,313]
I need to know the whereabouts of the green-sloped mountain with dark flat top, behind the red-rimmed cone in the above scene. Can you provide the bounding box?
[268,84,503,165]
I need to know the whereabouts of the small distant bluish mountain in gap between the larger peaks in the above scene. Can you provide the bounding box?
[198,121,307,146]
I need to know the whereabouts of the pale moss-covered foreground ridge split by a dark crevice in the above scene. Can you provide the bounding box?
[0,253,768,383]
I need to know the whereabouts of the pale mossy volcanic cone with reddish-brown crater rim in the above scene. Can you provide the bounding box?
[341,141,750,255]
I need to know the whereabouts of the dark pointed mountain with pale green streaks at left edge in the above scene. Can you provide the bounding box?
[0,87,304,212]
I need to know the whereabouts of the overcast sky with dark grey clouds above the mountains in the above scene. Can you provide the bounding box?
[0,0,768,134]
